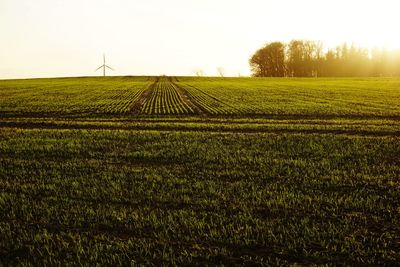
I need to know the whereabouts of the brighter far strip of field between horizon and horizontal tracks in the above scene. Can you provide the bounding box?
[0,77,400,117]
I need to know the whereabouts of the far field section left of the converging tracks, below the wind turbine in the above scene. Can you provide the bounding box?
[0,78,152,114]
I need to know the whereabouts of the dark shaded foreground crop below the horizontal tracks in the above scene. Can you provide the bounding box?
[0,128,400,265]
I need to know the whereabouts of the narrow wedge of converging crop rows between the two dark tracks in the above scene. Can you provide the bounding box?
[142,78,194,114]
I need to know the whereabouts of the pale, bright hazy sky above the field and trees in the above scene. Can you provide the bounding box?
[0,0,400,79]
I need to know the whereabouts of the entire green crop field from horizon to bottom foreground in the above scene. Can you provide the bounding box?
[0,77,400,266]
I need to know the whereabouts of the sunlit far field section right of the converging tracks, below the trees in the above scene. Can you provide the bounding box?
[178,77,400,117]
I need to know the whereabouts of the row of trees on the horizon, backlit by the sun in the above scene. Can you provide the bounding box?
[250,40,400,77]
